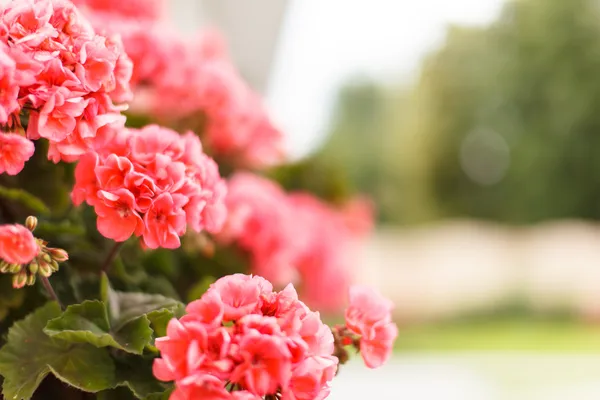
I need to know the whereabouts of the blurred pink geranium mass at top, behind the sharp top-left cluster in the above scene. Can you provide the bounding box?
[72,0,283,167]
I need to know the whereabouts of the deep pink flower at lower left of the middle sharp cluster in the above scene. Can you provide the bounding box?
[94,189,144,242]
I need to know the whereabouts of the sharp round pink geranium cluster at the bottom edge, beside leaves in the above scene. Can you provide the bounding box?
[154,274,338,400]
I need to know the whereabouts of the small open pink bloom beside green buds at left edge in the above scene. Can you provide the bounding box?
[0,225,40,264]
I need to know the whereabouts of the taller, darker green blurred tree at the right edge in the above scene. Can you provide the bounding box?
[417,0,600,223]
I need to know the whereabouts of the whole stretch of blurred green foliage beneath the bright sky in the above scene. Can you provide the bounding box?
[315,0,600,224]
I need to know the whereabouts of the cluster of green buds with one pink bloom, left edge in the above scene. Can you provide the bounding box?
[0,216,69,289]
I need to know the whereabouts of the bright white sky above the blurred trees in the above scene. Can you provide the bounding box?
[267,0,502,157]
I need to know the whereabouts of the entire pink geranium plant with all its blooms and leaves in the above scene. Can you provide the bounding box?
[0,0,397,400]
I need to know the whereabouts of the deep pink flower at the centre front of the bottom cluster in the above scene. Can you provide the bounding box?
[231,331,291,396]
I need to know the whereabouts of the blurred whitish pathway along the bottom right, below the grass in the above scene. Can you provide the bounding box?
[329,353,600,400]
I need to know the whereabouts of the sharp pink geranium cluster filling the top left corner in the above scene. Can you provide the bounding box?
[0,0,132,174]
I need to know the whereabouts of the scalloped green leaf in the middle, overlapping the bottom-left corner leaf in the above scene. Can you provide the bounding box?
[44,300,152,354]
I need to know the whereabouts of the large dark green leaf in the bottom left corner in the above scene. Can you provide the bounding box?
[0,302,118,400]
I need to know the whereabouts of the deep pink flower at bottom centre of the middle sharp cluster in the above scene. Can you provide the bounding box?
[143,192,188,249]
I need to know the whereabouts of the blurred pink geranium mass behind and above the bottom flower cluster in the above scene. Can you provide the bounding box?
[217,173,372,310]
